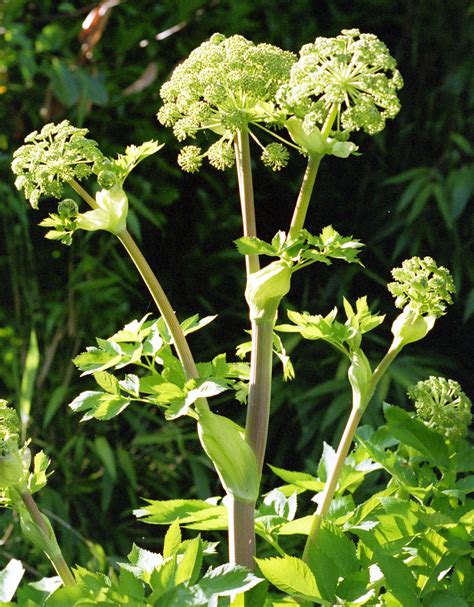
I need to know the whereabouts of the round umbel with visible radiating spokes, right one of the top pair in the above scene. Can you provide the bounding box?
[277,29,403,155]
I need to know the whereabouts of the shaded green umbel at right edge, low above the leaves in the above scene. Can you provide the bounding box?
[408,377,472,439]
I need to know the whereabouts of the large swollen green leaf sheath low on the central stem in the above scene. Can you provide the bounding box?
[198,410,259,502]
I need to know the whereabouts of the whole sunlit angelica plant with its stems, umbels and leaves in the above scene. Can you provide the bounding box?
[6,29,470,607]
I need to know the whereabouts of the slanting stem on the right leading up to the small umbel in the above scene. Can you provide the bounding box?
[303,344,401,561]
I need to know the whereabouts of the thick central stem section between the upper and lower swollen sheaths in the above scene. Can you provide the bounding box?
[245,319,275,475]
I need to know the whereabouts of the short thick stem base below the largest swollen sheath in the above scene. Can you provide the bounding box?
[228,495,255,571]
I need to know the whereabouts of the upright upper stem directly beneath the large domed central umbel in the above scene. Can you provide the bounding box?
[234,130,260,275]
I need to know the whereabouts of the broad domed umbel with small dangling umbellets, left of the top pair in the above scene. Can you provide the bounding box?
[158,34,296,170]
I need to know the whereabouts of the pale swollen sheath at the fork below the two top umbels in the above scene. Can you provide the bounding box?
[245,260,291,321]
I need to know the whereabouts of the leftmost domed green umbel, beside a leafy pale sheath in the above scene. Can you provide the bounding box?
[12,120,104,209]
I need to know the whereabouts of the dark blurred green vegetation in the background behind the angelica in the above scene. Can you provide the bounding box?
[0,0,474,574]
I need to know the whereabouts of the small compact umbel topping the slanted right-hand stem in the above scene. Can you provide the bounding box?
[387,257,455,318]
